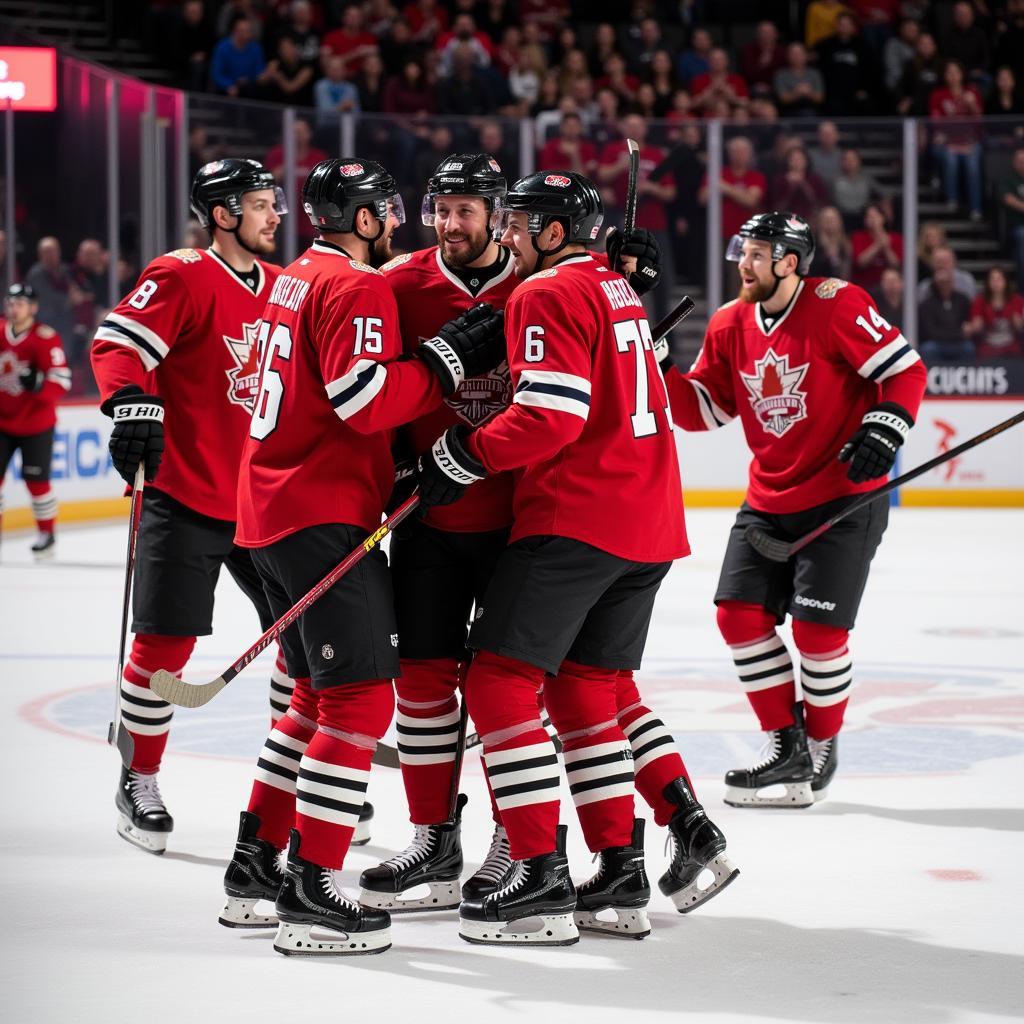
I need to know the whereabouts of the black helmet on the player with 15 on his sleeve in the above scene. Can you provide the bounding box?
[302,157,406,242]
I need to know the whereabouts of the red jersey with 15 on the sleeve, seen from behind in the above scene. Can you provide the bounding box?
[236,241,441,548]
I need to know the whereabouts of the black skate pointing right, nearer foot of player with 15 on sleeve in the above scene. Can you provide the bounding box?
[273,828,391,956]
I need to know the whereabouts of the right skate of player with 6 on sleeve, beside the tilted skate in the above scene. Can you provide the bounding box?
[573,818,650,939]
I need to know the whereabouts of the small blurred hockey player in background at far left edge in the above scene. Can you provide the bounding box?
[0,285,71,560]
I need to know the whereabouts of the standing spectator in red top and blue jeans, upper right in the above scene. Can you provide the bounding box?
[929,59,982,220]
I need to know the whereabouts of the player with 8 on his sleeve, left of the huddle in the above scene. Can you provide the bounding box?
[91,159,313,853]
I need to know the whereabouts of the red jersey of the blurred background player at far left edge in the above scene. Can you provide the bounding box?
[0,322,71,437]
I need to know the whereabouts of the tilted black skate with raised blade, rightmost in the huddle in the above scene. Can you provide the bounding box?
[657,772,739,913]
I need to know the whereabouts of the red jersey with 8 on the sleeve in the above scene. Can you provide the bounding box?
[92,249,281,521]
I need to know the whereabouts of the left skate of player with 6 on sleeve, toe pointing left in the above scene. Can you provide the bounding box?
[459,825,580,946]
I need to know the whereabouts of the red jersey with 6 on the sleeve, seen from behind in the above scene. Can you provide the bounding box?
[469,254,689,562]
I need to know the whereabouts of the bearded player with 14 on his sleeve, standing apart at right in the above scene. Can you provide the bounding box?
[658,212,926,807]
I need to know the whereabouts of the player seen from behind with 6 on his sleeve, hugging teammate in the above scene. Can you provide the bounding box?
[420,172,737,945]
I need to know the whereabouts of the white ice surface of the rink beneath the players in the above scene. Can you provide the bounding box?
[0,510,1024,1024]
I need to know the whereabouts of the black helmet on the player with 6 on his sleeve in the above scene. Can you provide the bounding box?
[492,171,604,247]
